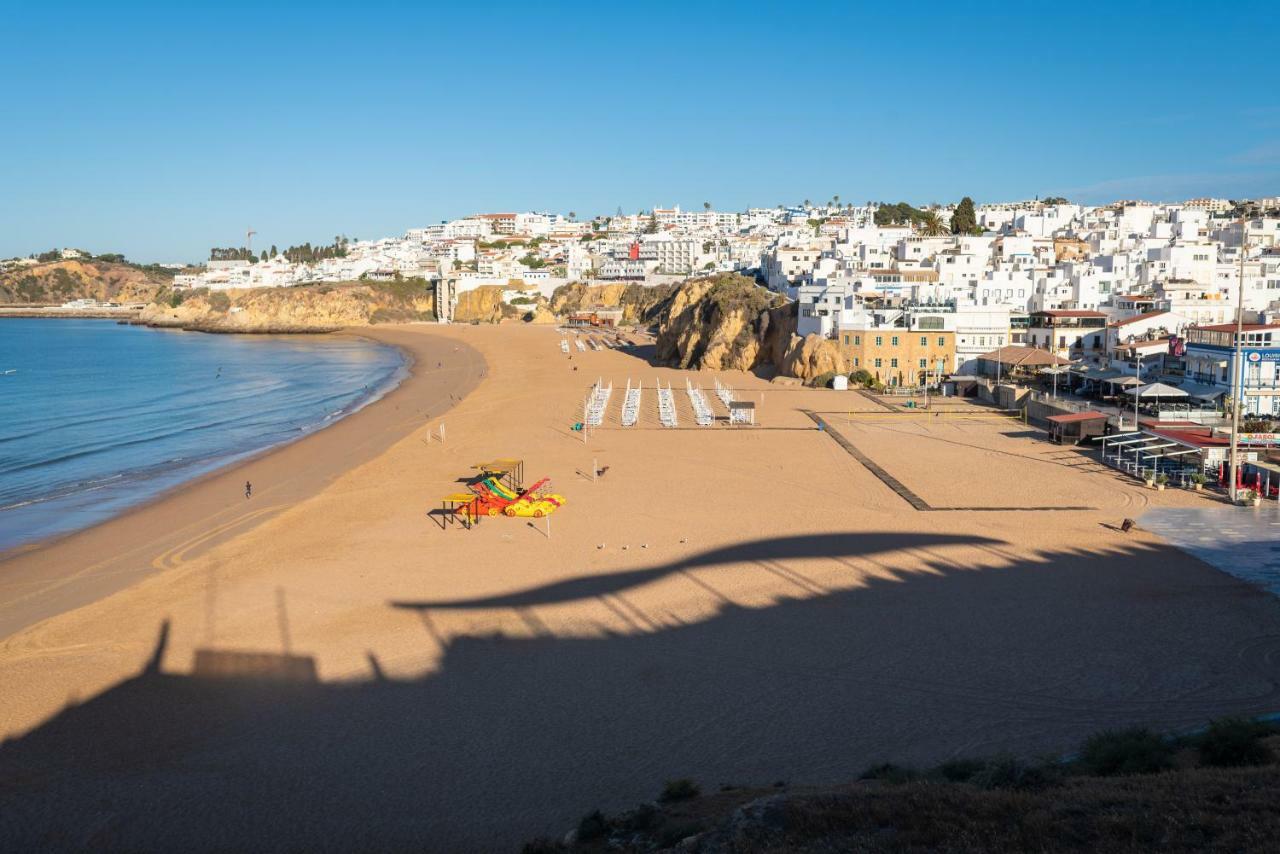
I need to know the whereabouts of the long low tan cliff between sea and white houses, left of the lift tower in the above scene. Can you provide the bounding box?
[138,282,435,333]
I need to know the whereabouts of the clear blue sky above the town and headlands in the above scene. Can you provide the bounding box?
[0,0,1280,261]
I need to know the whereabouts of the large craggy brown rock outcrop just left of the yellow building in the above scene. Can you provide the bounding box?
[657,274,847,380]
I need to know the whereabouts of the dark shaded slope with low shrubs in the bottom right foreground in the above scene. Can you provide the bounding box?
[524,718,1280,854]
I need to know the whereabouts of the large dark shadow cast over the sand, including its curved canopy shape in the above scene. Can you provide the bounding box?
[0,533,1280,851]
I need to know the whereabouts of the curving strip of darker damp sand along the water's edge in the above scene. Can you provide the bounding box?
[0,326,486,639]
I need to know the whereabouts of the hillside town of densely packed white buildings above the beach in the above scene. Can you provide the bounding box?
[152,196,1280,417]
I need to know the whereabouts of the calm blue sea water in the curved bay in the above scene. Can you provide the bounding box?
[0,319,404,551]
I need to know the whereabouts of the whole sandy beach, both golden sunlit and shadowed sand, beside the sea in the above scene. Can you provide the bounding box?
[0,326,1280,851]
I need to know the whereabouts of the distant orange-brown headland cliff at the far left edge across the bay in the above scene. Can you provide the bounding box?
[0,261,173,305]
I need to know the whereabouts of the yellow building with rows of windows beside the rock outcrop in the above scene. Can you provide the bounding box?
[840,327,956,385]
